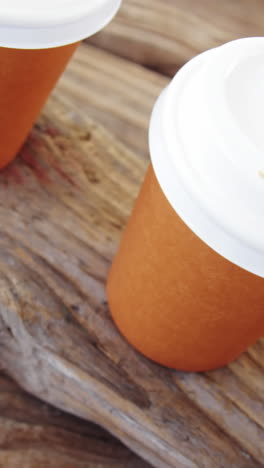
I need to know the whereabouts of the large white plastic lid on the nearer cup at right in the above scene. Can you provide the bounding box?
[150,37,264,277]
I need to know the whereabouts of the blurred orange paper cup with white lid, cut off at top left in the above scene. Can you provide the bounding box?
[0,0,121,169]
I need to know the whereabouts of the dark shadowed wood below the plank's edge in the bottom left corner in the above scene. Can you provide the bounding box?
[0,372,149,468]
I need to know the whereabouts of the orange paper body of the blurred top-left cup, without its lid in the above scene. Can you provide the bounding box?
[0,43,78,169]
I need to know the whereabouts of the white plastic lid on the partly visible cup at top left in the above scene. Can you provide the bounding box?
[0,0,121,49]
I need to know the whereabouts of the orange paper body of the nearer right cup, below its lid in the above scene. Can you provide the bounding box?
[107,166,264,371]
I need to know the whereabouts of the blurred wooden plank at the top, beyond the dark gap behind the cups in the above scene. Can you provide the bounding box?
[88,0,264,76]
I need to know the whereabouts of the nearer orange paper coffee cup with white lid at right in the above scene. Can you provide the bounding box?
[107,38,264,371]
